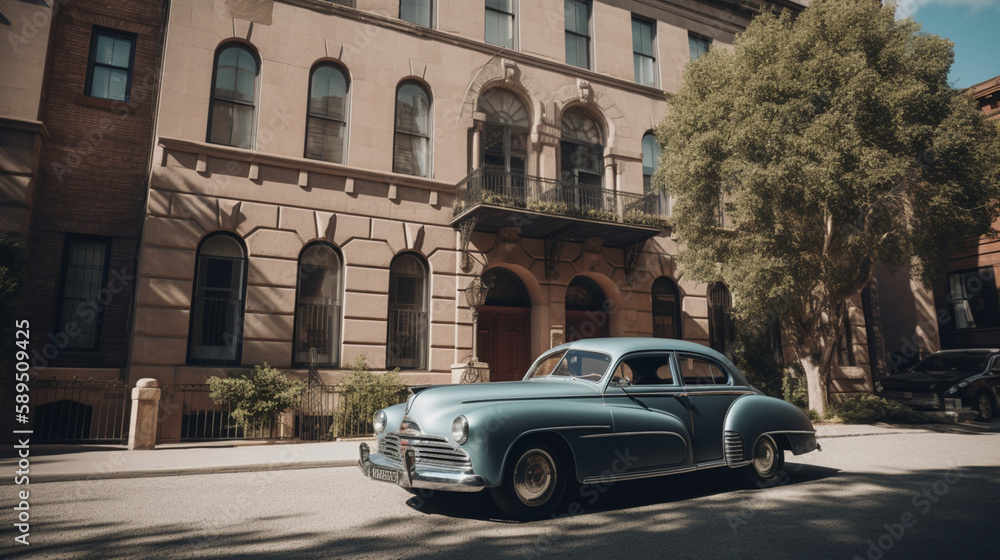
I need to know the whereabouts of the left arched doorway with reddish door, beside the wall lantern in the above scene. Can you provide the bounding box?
[476,268,532,381]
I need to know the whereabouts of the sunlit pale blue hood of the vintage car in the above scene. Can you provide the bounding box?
[398,379,601,435]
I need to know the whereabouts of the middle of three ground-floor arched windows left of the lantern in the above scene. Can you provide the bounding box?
[292,242,341,367]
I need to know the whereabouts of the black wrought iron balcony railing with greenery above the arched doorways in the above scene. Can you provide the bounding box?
[455,167,669,227]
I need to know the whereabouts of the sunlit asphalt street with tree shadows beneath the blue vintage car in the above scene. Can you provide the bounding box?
[9,427,1000,560]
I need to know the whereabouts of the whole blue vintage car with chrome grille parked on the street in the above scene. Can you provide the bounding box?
[359,338,819,518]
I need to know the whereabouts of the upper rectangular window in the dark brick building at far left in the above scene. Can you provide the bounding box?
[86,27,135,101]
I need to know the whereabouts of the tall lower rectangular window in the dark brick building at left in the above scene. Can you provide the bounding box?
[53,235,111,351]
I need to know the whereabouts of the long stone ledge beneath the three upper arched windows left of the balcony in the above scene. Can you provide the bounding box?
[157,137,455,193]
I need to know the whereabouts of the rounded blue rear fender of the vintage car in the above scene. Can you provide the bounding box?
[724,395,818,466]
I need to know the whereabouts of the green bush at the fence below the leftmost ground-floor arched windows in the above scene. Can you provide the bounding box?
[208,362,305,435]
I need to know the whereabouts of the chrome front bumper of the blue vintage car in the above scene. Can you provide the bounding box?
[358,443,486,492]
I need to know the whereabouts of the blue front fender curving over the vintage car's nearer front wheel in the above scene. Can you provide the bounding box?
[461,401,612,486]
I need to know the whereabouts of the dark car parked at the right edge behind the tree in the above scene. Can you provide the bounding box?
[878,348,1000,420]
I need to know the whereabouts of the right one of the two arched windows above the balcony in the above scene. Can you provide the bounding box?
[559,107,604,187]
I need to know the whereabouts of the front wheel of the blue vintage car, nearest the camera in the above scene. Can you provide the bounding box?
[492,442,569,519]
